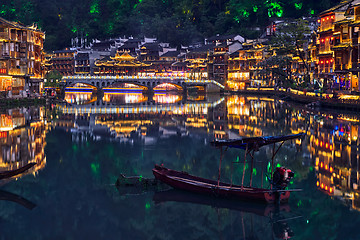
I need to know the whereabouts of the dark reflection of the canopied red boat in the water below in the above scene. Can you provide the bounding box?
[153,189,301,239]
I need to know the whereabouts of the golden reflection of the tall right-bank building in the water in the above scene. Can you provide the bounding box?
[309,115,360,210]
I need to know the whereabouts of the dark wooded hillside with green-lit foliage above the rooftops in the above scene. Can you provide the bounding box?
[0,0,338,50]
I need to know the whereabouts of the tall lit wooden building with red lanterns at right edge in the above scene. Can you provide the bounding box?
[317,0,360,91]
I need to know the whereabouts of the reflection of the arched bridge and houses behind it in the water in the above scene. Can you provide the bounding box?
[51,93,225,144]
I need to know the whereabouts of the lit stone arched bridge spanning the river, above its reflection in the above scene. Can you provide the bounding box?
[63,75,224,92]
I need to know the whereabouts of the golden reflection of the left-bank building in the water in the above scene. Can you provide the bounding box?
[0,108,46,177]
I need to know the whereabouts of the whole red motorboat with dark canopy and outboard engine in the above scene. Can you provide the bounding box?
[152,134,303,203]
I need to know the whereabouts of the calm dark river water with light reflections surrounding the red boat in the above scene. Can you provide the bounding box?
[0,93,360,240]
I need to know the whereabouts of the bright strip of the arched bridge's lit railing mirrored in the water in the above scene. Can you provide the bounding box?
[59,98,224,115]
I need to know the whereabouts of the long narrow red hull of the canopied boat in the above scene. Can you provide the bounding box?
[152,165,290,203]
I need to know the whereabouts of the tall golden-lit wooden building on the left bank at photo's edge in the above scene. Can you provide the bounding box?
[0,18,45,95]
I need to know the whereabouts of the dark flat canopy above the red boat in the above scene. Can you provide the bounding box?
[211,133,305,150]
